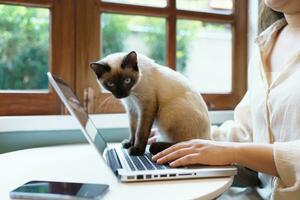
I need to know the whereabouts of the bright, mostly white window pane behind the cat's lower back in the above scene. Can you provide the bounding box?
[176,20,232,93]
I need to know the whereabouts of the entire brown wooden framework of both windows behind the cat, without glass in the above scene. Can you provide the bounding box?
[0,0,248,115]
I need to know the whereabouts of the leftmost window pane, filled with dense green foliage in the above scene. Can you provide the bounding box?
[0,5,49,90]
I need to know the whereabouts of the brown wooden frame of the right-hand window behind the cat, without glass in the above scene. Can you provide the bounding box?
[76,0,248,113]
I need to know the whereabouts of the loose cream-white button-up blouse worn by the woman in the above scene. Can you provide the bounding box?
[212,19,300,200]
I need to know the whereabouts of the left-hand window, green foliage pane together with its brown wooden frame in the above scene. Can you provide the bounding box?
[0,0,74,115]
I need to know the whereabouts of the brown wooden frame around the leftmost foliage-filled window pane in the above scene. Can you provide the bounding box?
[0,0,75,115]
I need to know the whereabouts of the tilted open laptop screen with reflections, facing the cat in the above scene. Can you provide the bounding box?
[47,72,107,154]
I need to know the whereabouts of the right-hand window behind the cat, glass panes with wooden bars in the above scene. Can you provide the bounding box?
[96,0,247,112]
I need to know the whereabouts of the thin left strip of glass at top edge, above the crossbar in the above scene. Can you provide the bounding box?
[102,0,167,8]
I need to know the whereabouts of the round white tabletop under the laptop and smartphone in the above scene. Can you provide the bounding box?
[0,144,233,200]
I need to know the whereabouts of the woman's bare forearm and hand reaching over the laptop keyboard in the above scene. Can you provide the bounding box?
[153,139,277,176]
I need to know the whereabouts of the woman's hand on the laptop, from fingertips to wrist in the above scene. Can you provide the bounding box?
[152,139,236,167]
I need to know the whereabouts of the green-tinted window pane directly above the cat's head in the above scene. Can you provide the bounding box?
[101,13,166,64]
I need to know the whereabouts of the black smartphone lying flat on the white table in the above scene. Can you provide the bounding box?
[10,181,109,200]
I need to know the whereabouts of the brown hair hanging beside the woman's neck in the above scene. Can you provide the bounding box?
[259,0,284,32]
